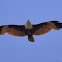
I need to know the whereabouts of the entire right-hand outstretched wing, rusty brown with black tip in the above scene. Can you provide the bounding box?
[32,21,62,35]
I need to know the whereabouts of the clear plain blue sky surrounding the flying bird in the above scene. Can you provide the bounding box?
[0,0,62,62]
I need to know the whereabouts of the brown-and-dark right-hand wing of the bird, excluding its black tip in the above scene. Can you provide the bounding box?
[32,22,57,35]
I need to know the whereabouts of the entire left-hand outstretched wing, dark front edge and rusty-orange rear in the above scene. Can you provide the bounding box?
[0,25,26,36]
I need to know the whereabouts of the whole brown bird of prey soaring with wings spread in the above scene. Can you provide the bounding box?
[0,20,62,42]
